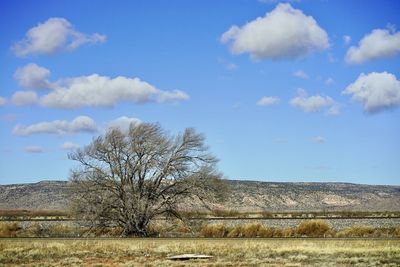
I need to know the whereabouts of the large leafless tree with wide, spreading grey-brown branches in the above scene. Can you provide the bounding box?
[69,123,220,236]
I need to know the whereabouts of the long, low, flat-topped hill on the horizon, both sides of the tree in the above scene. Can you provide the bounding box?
[0,180,400,211]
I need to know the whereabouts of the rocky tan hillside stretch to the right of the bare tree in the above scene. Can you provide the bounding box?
[222,181,400,211]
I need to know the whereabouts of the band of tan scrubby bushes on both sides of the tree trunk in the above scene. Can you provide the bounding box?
[0,220,400,238]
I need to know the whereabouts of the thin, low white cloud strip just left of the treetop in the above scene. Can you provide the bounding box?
[13,116,97,136]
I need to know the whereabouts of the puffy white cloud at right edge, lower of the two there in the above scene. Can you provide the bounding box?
[343,72,400,113]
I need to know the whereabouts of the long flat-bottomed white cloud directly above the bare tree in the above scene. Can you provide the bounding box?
[40,74,189,108]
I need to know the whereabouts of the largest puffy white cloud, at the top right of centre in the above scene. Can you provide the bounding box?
[220,4,329,59]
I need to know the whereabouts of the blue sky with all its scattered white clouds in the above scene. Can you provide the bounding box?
[0,0,400,185]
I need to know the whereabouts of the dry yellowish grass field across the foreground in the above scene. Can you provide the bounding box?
[0,239,400,266]
